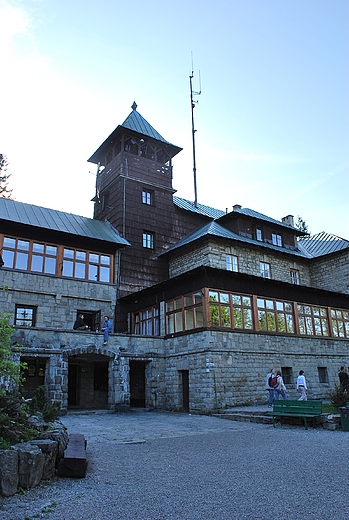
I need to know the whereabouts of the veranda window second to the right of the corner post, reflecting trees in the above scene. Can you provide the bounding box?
[257,298,294,333]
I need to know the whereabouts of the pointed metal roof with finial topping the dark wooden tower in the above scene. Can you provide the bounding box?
[88,102,182,163]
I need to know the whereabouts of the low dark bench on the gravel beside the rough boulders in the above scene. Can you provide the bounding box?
[58,433,87,478]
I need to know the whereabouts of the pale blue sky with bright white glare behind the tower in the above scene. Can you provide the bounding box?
[0,0,349,239]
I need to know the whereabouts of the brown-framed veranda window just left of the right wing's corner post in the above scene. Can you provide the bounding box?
[166,291,204,334]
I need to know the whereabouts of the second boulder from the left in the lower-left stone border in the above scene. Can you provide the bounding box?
[11,442,45,489]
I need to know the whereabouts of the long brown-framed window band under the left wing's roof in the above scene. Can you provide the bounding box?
[0,235,112,283]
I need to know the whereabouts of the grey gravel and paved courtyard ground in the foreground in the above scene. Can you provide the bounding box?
[0,411,349,520]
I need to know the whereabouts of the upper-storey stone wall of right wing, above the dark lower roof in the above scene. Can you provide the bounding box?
[169,240,310,286]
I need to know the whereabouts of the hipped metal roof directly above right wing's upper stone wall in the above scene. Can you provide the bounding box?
[162,221,309,258]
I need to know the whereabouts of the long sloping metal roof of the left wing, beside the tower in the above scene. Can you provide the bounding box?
[0,197,130,246]
